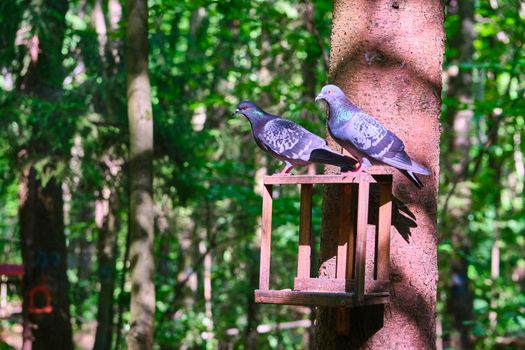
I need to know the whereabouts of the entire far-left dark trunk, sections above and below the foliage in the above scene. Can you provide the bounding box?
[16,0,73,350]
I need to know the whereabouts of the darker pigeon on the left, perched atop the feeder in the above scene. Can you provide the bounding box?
[235,101,357,175]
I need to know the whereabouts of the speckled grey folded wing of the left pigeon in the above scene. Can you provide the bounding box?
[258,118,327,161]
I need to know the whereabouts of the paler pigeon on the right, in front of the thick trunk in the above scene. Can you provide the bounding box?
[315,85,431,188]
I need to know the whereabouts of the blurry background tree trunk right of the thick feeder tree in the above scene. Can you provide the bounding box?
[441,0,475,349]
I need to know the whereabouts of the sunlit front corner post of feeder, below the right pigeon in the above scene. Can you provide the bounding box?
[355,182,370,302]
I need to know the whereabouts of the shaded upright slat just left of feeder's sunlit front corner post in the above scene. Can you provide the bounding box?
[335,184,353,279]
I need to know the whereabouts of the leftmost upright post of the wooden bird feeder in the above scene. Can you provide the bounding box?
[259,185,273,290]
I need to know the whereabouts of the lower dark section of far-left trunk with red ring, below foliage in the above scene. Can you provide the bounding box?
[20,167,73,350]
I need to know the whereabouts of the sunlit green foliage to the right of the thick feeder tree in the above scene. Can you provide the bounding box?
[439,0,525,349]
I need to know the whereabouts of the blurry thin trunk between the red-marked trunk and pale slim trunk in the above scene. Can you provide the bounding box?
[92,0,124,349]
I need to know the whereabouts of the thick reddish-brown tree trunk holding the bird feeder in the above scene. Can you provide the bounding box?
[317,0,444,349]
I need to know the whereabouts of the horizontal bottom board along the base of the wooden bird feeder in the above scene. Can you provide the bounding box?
[254,290,390,308]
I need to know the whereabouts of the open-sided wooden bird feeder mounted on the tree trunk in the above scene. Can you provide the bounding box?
[255,174,392,308]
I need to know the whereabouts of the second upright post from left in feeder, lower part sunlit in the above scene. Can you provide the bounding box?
[297,184,313,278]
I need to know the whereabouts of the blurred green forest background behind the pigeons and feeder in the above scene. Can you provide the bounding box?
[0,0,525,349]
